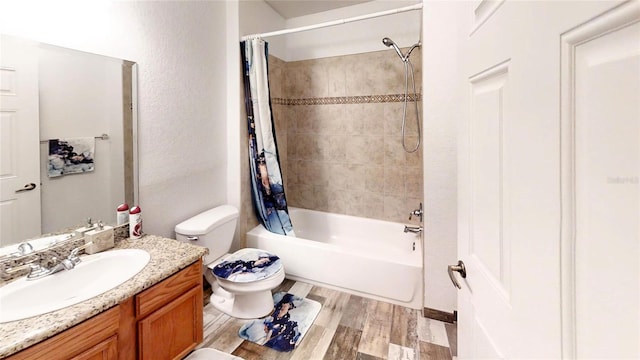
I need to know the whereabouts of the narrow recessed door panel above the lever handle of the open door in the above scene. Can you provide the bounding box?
[469,62,509,297]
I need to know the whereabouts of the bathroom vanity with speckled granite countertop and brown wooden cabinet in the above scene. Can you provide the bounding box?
[0,235,207,360]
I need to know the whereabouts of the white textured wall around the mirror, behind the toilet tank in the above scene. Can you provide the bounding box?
[0,0,227,237]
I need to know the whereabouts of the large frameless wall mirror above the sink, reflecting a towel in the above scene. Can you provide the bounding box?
[0,35,138,250]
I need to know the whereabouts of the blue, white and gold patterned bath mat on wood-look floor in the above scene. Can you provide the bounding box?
[238,292,322,352]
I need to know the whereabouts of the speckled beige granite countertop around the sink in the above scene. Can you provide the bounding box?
[0,235,208,359]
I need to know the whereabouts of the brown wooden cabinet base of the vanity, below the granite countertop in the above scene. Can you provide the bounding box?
[6,260,203,360]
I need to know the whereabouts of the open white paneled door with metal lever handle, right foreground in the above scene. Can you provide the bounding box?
[454,1,640,359]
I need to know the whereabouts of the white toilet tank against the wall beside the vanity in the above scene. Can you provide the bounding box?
[175,205,238,264]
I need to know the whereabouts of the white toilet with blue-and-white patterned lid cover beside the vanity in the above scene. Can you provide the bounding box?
[175,205,285,319]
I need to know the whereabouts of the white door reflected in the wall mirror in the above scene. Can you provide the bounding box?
[0,35,41,246]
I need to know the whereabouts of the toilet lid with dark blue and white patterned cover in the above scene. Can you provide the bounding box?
[211,248,282,283]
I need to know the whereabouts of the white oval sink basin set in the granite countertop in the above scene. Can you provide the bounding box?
[0,249,150,323]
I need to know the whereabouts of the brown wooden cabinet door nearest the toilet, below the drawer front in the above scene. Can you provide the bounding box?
[138,286,203,360]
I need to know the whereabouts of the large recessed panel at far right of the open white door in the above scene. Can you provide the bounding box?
[562,2,640,358]
